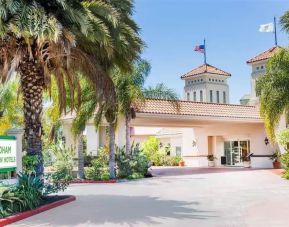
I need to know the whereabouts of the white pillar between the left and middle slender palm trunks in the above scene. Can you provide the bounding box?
[86,125,99,155]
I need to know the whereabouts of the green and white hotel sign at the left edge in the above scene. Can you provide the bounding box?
[0,136,17,169]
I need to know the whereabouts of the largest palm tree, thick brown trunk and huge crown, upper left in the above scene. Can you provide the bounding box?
[0,0,142,176]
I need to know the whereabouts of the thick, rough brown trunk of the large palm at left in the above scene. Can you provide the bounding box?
[19,55,44,178]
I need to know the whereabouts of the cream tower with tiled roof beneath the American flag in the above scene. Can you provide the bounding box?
[181,64,231,103]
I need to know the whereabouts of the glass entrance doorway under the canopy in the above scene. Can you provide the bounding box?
[224,140,250,166]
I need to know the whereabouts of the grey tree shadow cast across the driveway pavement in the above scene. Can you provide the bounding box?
[14,195,214,226]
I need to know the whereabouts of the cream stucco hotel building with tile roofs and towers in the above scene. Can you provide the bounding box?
[63,47,286,168]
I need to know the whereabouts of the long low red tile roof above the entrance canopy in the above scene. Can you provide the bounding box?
[135,99,261,119]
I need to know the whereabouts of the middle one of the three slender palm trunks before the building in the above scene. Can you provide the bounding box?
[109,123,115,179]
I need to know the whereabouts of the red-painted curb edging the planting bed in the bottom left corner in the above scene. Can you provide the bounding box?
[0,196,76,226]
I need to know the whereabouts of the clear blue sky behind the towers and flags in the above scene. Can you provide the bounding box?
[134,0,289,103]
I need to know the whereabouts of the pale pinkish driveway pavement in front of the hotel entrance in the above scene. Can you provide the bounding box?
[10,169,289,227]
